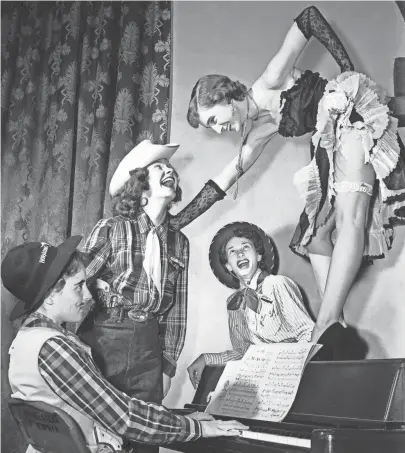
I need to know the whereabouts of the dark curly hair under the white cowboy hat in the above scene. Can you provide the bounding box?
[113,167,182,218]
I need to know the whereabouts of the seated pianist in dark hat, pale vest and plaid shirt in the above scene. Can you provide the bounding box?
[1,236,246,453]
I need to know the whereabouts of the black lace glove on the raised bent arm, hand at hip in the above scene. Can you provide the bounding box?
[295,6,354,72]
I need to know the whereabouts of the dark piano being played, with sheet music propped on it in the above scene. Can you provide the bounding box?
[170,359,405,453]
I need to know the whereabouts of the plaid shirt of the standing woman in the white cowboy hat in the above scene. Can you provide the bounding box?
[82,211,189,376]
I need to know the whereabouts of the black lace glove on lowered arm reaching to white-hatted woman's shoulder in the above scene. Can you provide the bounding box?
[170,179,226,230]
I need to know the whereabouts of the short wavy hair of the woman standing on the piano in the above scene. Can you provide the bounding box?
[187,74,247,129]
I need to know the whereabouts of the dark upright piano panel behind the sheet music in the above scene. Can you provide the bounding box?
[192,359,405,427]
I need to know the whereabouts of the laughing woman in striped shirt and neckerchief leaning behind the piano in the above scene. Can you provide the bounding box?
[188,222,318,388]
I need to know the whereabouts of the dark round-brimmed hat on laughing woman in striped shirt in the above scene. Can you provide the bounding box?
[209,222,275,289]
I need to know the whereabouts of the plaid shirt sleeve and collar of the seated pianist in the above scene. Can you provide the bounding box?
[24,315,201,444]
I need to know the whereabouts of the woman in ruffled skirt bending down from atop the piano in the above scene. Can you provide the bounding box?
[187,6,405,341]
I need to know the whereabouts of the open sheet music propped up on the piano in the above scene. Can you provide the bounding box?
[206,343,319,421]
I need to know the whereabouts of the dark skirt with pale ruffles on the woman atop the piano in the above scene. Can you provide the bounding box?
[290,72,405,259]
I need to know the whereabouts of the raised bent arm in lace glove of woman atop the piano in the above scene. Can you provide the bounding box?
[262,6,354,88]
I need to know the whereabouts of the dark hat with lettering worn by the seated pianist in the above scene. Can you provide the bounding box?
[1,236,82,321]
